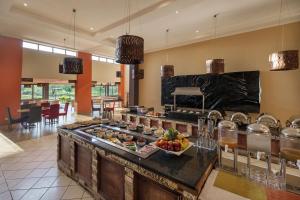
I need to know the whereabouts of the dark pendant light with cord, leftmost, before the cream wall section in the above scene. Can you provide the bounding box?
[59,9,83,74]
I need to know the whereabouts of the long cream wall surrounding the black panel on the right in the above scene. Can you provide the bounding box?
[139,22,300,122]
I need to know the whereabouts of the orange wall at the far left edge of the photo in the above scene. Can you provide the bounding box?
[0,36,22,124]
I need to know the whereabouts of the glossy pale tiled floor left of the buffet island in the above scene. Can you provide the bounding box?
[0,113,93,200]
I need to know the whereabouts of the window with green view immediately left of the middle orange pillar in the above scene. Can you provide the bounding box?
[49,84,75,102]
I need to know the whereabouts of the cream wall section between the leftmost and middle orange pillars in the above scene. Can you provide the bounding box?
[22,48,76,80]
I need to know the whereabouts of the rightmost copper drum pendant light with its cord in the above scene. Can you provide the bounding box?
[269,0,299,71]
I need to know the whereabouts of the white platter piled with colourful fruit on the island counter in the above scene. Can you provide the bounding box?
[152,128,193,156]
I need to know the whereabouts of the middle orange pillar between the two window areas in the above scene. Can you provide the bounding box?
[75,52,92,114]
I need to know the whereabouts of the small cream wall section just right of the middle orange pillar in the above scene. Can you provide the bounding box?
[92,61,120,83]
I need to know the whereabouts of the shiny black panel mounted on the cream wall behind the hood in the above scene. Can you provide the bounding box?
[161,71,260,113]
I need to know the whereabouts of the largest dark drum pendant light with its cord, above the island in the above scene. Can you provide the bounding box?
[115,0,144,64]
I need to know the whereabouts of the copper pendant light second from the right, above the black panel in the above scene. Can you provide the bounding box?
[206,14,224,74]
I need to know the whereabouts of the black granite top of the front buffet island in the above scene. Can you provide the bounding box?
[59,129,217,189]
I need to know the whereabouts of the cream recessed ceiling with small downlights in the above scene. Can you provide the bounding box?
[0,0,300,56]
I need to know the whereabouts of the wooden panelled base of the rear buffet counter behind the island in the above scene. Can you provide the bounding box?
[122,113,280,156]
